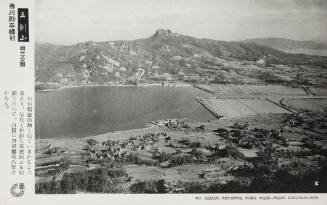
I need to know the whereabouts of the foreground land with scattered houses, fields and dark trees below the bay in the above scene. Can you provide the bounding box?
[35,87,327,193]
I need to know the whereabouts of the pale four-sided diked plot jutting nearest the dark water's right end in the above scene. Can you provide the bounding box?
[202,98,290,118]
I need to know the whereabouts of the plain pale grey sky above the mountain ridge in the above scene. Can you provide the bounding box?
[35,0,327,44]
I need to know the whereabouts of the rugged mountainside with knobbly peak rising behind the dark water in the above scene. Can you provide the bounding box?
[35,29,327,86]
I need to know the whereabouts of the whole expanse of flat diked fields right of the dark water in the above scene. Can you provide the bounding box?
[195,85,327,118]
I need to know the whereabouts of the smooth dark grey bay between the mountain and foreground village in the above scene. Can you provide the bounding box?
[36,86,215,139]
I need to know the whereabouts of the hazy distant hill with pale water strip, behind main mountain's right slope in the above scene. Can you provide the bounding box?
[241,38,327,55]
